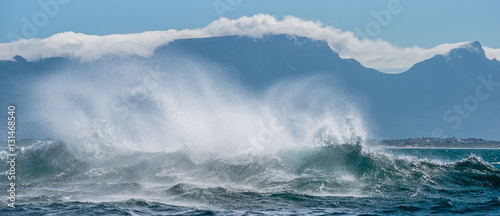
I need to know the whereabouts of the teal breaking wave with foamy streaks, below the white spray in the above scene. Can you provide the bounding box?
[2,140,500,203]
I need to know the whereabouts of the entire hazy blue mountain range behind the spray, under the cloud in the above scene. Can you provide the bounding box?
[0,35,500,140]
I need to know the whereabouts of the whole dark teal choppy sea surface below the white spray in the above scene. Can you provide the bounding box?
[0,140,500,215]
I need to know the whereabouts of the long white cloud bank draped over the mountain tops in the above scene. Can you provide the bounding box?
[0,14,500,72]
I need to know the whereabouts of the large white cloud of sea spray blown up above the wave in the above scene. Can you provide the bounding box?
[34,54,366,156]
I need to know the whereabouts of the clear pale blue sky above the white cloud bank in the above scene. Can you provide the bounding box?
[0,0,500,48]
